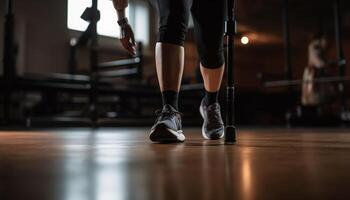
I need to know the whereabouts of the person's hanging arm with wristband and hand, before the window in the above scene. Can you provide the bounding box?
[113,0,136,56]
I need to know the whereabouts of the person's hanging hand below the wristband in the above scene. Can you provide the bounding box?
[120,23,136,56]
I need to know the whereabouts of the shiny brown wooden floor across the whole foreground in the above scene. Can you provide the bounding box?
[0,128,350,200]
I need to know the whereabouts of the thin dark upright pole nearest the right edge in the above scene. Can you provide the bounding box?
[334,0,347,117]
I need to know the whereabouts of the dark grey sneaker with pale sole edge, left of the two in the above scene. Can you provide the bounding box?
[149,105,185,143]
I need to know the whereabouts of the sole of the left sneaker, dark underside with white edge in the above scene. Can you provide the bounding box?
[149,124,185,143]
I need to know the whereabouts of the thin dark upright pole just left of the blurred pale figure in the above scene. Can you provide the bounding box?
[282,0,292,126]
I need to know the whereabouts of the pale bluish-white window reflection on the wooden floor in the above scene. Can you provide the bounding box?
[64,132,129,200]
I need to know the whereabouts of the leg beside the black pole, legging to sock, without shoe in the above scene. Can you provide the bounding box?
[192,0,225,106]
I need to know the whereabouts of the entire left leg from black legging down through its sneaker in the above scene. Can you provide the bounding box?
[150,0,191,142]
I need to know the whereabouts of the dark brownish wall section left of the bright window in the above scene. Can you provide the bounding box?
[14,0,68,73]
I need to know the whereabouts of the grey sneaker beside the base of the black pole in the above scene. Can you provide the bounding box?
[199,100,224,140]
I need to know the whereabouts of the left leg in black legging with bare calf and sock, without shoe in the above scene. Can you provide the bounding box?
[156,0,191,110]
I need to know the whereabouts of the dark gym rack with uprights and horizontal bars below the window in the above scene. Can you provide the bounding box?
[0,0,145,124]
